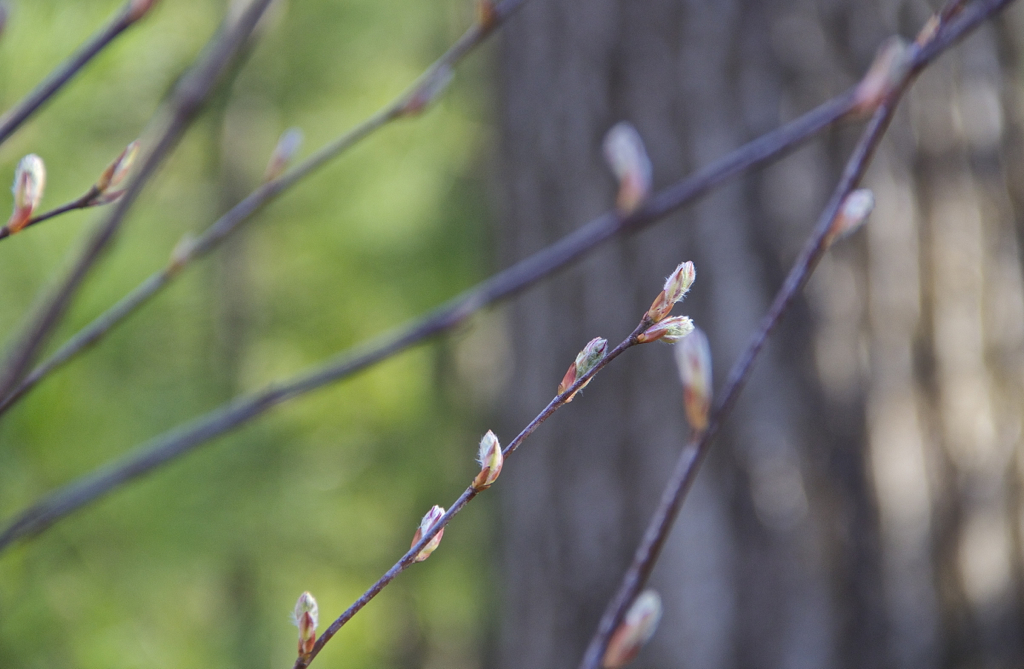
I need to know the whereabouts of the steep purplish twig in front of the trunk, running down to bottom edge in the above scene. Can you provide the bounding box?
[580,0,1013,669]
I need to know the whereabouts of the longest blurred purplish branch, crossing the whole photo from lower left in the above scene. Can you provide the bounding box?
[0,0,999,550]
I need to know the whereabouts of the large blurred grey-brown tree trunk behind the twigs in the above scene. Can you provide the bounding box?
[500,0,1024,669]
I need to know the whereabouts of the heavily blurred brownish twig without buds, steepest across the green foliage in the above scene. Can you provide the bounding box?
[0,0,270,411]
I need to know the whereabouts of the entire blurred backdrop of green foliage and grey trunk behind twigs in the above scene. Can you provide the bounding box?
[0,0,1024,669]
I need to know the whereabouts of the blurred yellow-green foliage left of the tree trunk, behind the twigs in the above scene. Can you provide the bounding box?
[0,0,494,669]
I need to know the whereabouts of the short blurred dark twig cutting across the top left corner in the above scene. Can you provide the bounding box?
[0,0,155,143]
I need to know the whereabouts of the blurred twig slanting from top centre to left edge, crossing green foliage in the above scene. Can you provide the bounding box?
[0,0,525,414]
